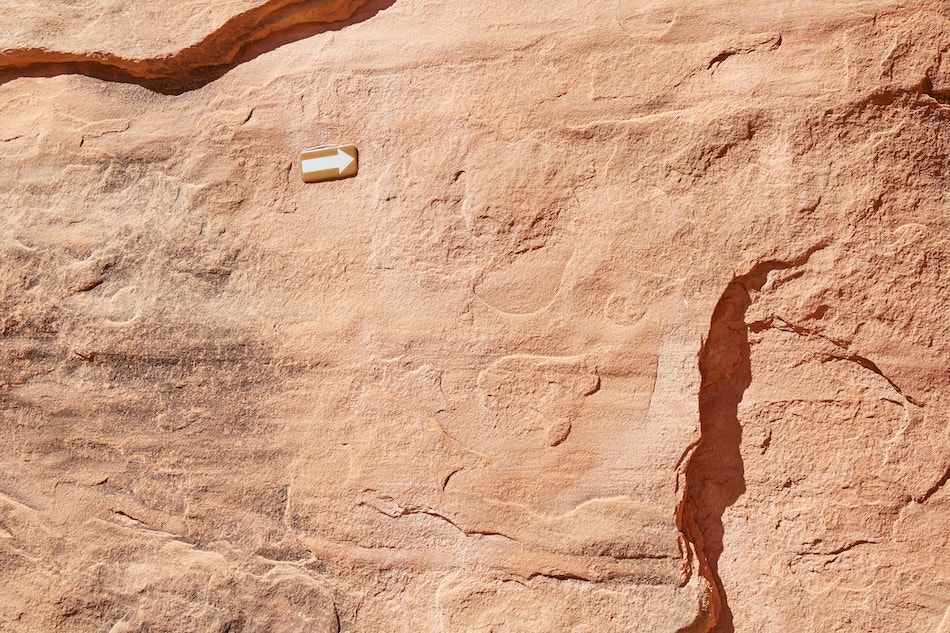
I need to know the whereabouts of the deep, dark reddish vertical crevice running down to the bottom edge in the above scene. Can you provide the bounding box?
[676,245,824,633]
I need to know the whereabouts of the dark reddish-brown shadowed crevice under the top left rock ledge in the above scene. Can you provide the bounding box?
[0,0,396,95]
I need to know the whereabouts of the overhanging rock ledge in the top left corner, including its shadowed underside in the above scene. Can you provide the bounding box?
[0,0,393,94]
